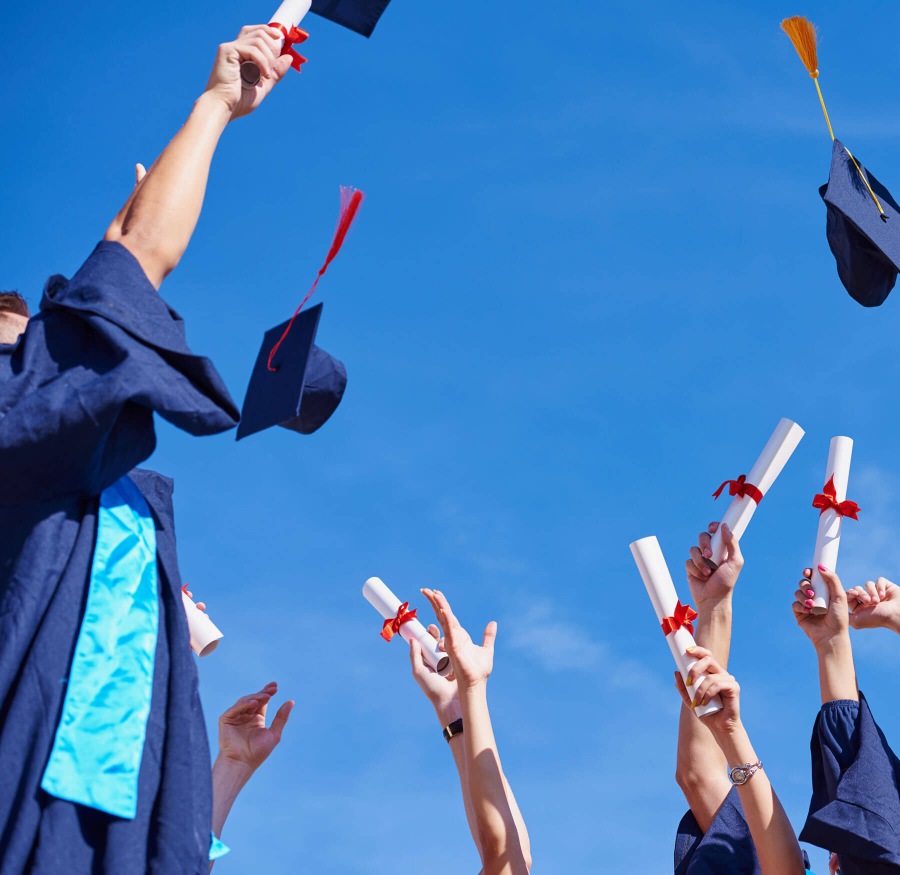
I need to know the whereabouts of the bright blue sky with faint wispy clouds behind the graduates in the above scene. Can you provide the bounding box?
[0,0,900,875]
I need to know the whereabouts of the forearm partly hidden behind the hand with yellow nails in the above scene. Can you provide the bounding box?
[675,599,731,832]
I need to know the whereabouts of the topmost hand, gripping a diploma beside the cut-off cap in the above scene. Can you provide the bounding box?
[206,24,291,119]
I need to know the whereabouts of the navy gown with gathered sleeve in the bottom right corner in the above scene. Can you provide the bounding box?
[800,693,900,875]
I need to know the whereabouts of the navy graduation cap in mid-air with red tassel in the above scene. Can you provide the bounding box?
[236,186,364,440]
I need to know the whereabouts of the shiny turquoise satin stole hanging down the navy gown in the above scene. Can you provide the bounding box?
[41,477,159,819]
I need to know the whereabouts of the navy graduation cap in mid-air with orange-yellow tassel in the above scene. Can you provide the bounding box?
[781,15,900,307]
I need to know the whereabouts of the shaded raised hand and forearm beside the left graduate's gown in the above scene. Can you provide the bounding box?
[210,681,294,869]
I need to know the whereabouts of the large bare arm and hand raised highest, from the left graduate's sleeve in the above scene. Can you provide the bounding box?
[105,24,291,288]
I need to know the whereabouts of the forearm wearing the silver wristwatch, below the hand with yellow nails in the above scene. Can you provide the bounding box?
[718,726,806,875]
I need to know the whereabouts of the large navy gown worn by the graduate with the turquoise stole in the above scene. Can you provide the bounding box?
[0,243,237,875]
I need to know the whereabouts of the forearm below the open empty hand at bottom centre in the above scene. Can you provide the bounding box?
[460,684,528,875]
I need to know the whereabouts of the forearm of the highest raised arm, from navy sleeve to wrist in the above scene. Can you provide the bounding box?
[105,92,230,288]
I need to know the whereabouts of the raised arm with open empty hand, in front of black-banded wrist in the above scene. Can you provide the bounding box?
[422,589,531,875]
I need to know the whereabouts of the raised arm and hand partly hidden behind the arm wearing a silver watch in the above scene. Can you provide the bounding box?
[675,523,744,832]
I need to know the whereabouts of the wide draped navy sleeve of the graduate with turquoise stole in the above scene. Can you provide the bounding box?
[0,242,239,506]
